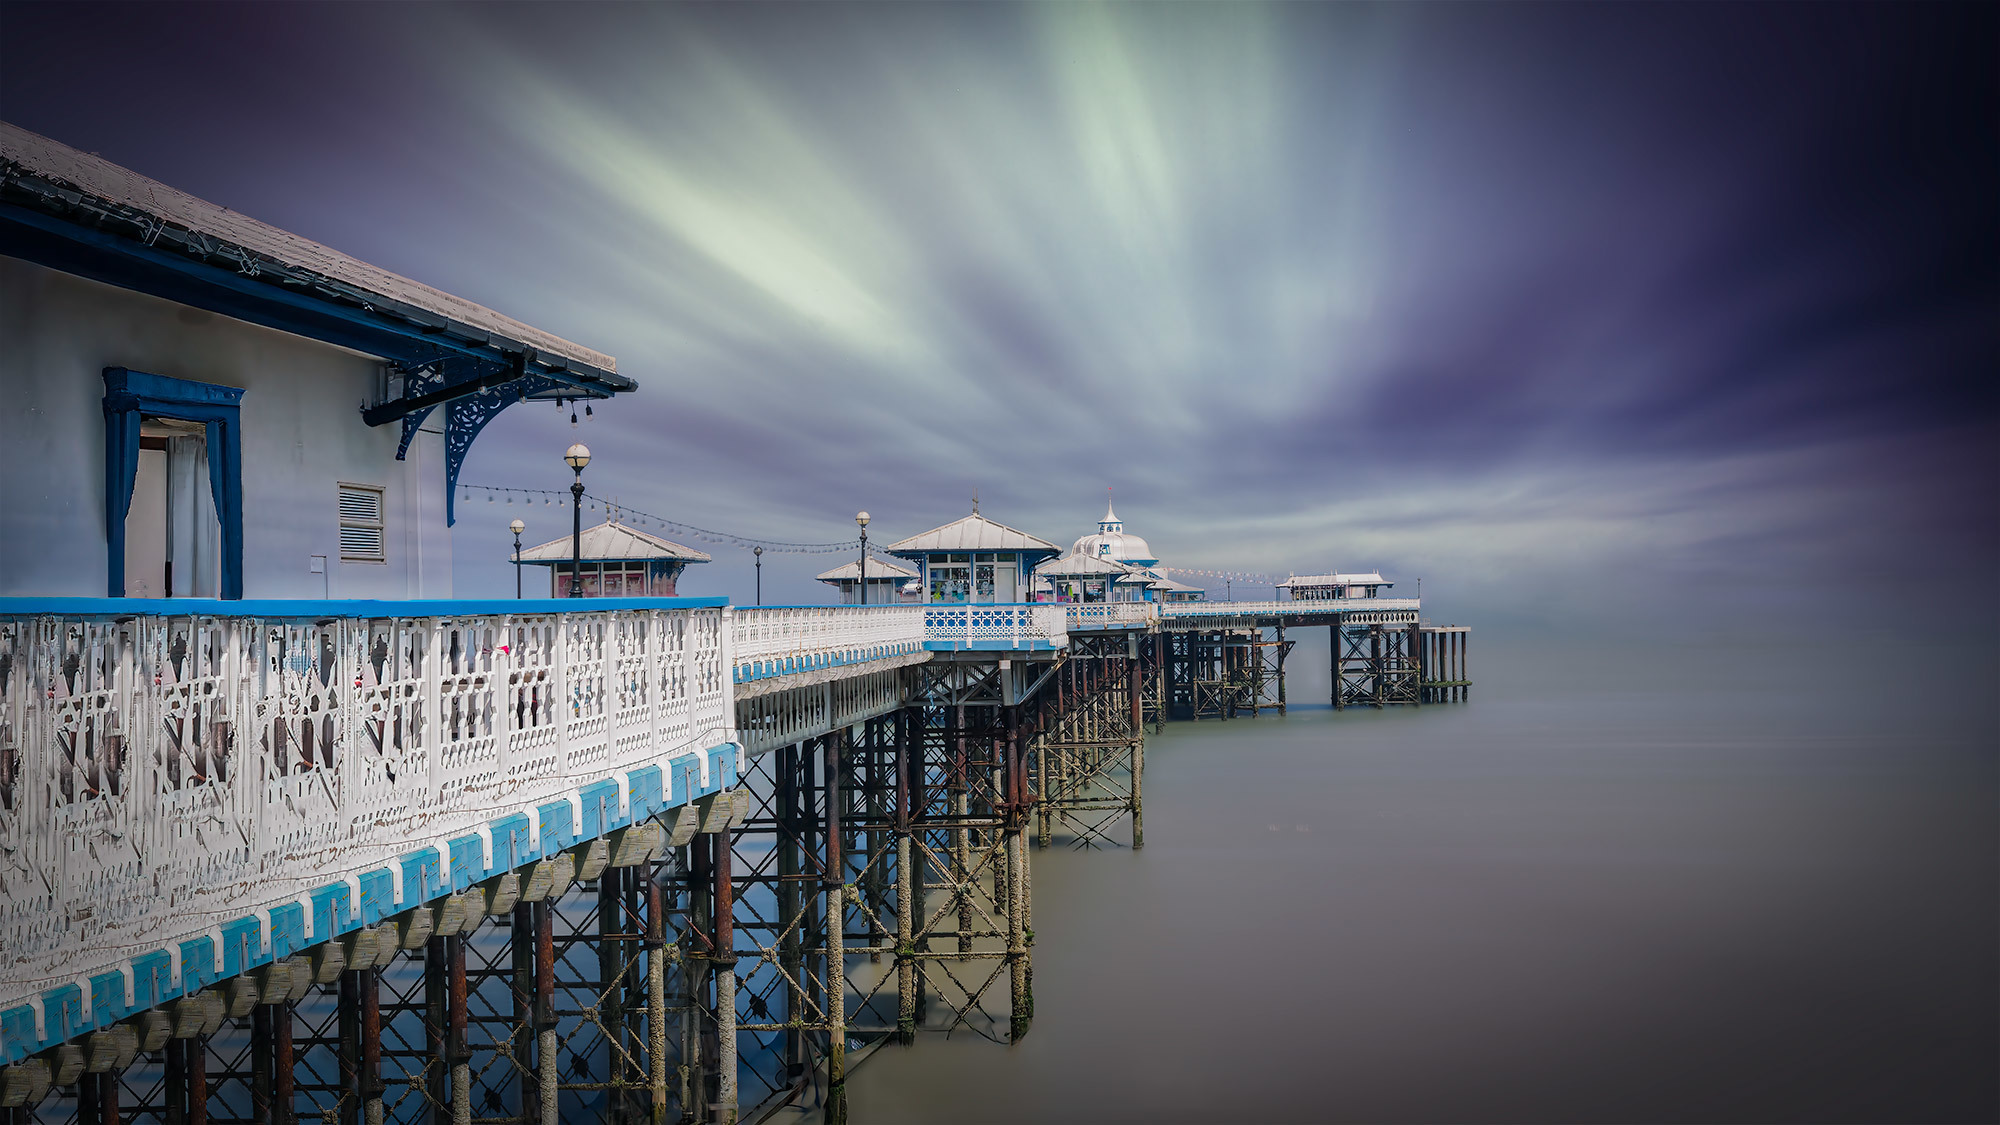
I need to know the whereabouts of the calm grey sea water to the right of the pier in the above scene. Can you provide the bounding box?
[850,640,2000,1123]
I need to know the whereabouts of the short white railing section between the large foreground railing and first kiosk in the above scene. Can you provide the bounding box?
[730,605,924,683]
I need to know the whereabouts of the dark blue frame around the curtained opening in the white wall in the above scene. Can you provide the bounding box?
[104,366,244,599]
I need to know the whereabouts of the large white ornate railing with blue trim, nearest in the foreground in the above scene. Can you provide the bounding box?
[0,599,740,1063]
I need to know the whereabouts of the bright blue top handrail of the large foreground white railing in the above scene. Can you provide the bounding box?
[0,597,730,621]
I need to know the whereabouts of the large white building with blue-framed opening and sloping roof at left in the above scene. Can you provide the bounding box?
[0,122,634,599]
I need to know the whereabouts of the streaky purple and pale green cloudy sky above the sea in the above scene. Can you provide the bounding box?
[0,4,2000,640]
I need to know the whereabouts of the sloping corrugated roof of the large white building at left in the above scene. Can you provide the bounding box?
[0,122,636,380]
